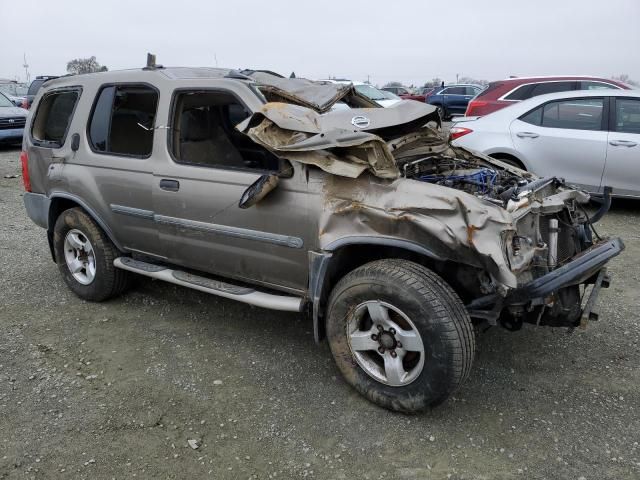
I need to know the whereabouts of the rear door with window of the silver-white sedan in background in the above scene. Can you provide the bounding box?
[510,97,608,192]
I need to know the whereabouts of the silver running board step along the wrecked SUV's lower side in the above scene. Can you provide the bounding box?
[113,257,303,312]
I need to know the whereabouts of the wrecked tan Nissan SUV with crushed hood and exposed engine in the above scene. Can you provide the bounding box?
[21,65,623,412]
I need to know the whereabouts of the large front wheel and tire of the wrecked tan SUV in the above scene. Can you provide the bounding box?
[326,259,475,413]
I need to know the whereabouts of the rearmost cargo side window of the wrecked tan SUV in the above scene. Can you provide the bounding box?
[31,89,80,148]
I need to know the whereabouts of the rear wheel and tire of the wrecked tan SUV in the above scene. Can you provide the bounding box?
[53,208,130,302]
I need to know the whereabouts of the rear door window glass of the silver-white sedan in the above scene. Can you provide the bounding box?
[520,98,604,130]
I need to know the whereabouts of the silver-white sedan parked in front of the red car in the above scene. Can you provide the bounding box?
[451,90,640,197]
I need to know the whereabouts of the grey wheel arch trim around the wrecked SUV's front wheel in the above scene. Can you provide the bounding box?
[308,236,447,343]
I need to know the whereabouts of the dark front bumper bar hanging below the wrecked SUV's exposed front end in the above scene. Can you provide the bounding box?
[466,238,625,317]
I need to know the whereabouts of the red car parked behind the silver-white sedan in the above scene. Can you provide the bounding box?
[464,76,631,117]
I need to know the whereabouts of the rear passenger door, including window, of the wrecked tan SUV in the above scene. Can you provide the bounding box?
[72,83,160,255]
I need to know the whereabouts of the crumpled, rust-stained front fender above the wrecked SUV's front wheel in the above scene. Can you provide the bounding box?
[320,175,518,288]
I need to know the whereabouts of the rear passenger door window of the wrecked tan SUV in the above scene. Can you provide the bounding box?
[88,85,158,157]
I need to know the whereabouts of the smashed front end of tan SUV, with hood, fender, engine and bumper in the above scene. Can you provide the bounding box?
[237,85,624,330]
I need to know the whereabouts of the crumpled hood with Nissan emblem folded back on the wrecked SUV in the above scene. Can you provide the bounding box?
[236,100,439,178]
